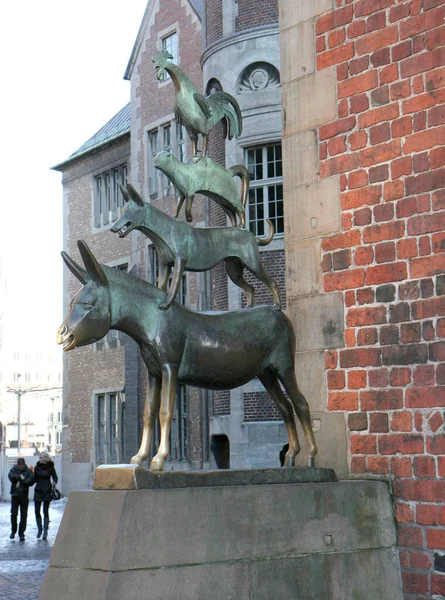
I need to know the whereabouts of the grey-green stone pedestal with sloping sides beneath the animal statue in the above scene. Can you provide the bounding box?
[39,481,402,600]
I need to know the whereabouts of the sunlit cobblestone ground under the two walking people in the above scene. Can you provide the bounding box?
[0,499,66,600]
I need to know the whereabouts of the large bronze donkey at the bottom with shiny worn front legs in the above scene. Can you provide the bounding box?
[57,241,317,471]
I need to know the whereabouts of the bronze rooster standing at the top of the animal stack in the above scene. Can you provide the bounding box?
[153,50,242,158]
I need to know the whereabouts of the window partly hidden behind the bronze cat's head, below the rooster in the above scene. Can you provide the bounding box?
[148,121,187,199]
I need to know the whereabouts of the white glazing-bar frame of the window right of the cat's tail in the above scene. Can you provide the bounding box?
[244,140,284,239]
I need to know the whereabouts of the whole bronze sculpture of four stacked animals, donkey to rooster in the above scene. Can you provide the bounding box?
[57,52,317,471]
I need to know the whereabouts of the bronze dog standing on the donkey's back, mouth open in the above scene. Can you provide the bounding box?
[111,184,281,310]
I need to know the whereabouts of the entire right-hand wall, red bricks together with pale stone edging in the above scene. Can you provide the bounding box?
[280,0,445,600]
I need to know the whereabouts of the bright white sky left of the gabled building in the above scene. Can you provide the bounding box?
[0,0,147,348]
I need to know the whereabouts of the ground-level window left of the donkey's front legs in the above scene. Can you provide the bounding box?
[95,392,124,464]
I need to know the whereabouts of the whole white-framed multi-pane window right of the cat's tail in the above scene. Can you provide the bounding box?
[246,144,284,237]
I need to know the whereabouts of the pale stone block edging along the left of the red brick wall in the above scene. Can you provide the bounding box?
[280,0,347,473]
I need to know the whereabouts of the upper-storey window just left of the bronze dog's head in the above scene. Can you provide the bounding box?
[93,164,127,227]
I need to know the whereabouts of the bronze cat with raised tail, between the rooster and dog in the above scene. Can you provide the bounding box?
[154,151,250,227]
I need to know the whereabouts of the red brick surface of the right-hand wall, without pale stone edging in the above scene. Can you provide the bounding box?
[316,0,445,600]
